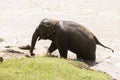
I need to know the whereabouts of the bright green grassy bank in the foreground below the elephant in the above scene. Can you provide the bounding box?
[0,57,111,80]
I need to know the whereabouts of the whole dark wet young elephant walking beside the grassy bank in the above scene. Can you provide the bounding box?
[30,19,113,61]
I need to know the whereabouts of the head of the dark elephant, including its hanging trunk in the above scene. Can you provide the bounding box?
[30,19,58,56]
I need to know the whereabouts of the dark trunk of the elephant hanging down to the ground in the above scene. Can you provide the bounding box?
[30,28,39,56]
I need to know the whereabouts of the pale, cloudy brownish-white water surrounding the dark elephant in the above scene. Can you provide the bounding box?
[0,0,120,80]
